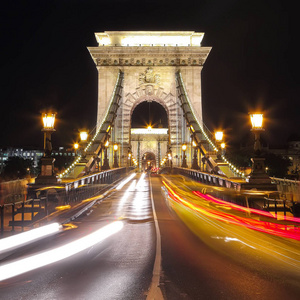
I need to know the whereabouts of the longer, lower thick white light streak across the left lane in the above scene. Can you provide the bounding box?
[0,221,124,281]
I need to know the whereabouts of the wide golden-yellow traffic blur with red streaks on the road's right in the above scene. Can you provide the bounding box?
[164,173,300,274]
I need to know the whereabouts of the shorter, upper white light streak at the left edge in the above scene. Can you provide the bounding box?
[0,223,62,253]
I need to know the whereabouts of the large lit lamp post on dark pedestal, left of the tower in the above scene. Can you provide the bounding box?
[35,112,57,184]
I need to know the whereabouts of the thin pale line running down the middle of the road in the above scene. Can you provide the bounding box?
[147,178,164,300]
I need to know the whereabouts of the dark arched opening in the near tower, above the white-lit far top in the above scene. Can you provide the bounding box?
[131,101,168,128]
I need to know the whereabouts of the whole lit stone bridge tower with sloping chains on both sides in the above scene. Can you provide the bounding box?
[60,31,243,178]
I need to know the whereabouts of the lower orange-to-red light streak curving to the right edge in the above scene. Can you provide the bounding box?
[163,181,300,241]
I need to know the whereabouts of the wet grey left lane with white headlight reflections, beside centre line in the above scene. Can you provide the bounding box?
[0,173,155,299]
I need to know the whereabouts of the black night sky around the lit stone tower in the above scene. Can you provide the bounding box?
[0,0,300,147]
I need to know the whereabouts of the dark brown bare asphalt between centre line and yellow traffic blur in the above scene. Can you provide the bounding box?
[152,178,299,299]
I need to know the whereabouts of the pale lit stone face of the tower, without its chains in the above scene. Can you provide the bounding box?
[88,31,211,168]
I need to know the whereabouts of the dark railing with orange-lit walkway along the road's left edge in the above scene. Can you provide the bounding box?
[0,167,133,236]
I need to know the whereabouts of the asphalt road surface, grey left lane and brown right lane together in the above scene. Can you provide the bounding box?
[0,175,300,300]
